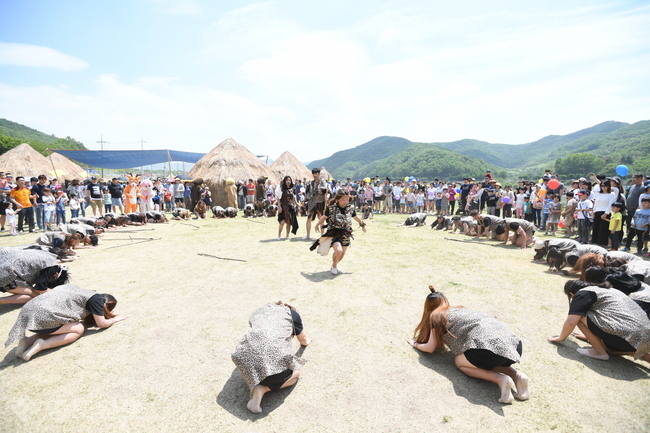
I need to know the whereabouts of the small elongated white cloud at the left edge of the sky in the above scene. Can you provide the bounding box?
[0,42,88,71]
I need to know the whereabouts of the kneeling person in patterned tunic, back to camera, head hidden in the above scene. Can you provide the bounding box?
[232,301,311,413]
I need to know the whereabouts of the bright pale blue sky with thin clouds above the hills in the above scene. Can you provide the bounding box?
[0,0,650,162]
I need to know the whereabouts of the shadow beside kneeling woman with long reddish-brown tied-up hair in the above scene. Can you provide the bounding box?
[413,349,506,416]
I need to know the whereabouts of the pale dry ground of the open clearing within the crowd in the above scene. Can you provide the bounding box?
[0,215,650,432]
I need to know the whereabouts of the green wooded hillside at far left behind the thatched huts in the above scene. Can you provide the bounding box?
[0,119,88,154]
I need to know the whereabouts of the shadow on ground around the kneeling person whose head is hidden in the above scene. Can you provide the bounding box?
[217,346,305,421]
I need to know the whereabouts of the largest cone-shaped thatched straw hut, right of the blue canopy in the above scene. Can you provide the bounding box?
[189,138,278,207]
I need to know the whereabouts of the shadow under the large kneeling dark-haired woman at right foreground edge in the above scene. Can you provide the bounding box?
[555,340,650,382]
